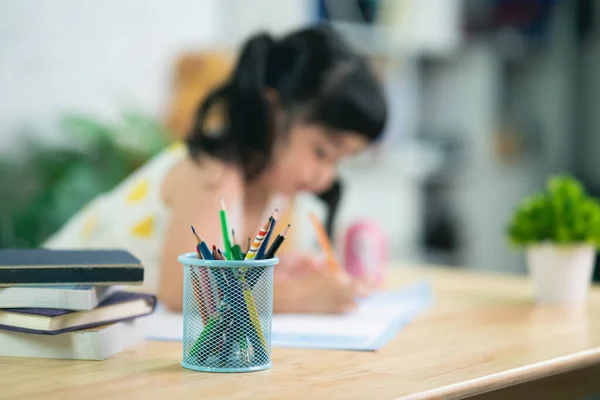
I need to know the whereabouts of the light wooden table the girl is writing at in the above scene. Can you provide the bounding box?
[0,267,600,400]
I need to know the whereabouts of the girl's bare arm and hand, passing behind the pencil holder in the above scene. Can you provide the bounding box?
[158,159,368,313]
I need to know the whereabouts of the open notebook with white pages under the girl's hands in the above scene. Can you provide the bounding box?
[141,281,432,351]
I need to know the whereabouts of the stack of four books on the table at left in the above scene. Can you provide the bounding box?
[0,249,156,360]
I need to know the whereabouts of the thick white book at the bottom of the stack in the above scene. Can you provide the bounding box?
[0,320,142,360]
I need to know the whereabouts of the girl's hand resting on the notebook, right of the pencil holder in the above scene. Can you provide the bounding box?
[274,255,371,313]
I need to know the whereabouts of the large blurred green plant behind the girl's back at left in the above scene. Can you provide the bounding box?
[0,112,170,247]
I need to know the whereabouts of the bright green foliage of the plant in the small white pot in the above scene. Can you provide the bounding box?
[508,175,600,248]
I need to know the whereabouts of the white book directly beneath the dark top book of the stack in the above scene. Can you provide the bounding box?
[0,286,119,311]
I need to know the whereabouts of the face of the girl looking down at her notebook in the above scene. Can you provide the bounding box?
[262,123,368,195]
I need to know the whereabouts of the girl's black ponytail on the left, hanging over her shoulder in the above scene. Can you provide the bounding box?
[187,34,275,179]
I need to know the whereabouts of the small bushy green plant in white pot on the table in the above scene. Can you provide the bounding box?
[508,175,600,305]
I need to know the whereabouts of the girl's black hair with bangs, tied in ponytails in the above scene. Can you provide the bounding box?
[187,25,387,238]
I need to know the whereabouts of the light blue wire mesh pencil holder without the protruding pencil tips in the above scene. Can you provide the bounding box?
[178,253,279,372]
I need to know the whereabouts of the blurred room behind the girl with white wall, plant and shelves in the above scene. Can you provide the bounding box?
[0,0,600,273]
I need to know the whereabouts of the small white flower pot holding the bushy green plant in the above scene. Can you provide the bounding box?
[527,243,596,305]
